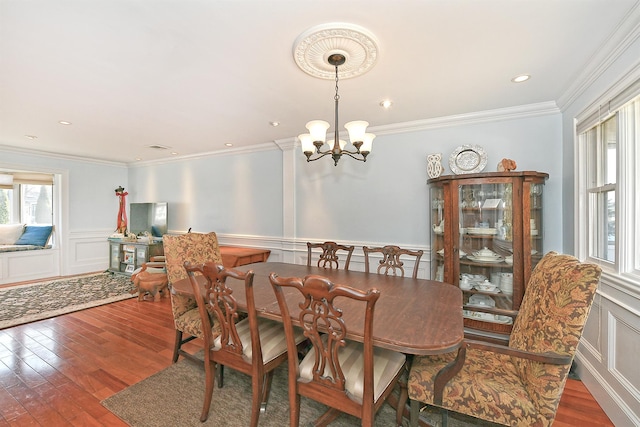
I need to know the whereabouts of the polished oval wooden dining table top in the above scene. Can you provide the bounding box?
[171,262,464,355]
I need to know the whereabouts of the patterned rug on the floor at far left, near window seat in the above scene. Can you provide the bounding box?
[0,273,135,329]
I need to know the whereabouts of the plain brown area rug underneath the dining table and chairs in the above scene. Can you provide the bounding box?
[102,360,489,427]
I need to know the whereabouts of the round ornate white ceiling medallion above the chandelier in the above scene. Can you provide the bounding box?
[293,23,380,80]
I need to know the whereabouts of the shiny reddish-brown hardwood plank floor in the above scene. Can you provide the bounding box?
[0,298,613,427]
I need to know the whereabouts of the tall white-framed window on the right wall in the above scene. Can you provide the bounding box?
[578,91,640,282]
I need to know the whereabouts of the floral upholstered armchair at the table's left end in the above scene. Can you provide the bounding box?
[162,232,222,363]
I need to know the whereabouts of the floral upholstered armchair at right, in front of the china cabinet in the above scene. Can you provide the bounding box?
[403,252,601,426]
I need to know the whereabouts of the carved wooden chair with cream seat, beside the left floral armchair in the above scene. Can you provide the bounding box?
[184,262,305,427]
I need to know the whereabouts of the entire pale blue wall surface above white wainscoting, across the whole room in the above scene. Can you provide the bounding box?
[0,108,563,256]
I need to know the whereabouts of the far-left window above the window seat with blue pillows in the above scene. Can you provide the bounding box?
[0,172,53,225]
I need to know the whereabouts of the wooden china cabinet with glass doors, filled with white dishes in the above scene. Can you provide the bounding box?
[428,171,549,341]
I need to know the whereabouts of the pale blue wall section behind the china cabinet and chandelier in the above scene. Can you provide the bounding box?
[295,112,562,250]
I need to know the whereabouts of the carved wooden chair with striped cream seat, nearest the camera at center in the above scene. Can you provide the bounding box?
[269,273,406,427]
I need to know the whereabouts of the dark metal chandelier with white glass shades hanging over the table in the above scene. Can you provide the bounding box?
[298,53,376,166]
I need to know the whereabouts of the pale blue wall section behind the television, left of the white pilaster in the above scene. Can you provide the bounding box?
[129,150,283,237]
